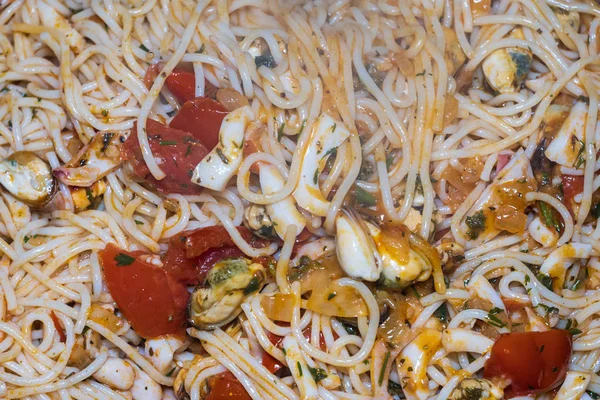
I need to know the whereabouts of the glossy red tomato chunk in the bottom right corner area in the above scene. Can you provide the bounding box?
[483,329,572,398]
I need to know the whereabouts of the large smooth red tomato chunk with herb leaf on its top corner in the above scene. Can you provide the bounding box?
[100,244,189,338]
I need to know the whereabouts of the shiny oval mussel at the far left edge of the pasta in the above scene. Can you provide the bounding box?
[0,151,57,207]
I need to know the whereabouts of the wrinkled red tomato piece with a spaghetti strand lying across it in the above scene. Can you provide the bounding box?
[121,119,208,194]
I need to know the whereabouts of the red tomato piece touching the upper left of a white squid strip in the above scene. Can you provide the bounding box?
[167,97,228,150]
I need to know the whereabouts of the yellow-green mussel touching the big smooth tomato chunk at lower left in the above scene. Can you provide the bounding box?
[188,257,267,329]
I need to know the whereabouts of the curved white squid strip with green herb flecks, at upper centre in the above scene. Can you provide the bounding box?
[294,114,350,217]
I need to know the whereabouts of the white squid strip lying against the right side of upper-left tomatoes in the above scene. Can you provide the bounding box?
[192,106,254,191]
